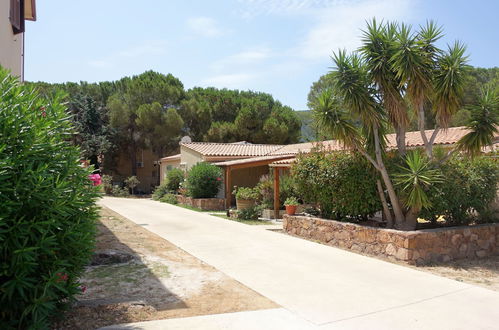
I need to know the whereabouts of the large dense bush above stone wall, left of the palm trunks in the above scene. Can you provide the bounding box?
[291,149,381,220]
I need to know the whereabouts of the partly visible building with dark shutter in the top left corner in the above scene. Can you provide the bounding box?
[0,0,36,81]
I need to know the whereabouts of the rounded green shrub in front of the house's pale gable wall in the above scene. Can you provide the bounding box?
[187,162,222,198]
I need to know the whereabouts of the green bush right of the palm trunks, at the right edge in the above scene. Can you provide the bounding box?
[421,156,499,225]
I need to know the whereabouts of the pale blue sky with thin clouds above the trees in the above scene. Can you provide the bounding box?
[25,0,499,110]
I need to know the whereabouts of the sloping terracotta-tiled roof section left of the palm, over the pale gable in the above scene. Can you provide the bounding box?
[180,142,283,157]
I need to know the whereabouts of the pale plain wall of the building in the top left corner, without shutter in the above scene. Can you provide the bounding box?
[0,0,23,78]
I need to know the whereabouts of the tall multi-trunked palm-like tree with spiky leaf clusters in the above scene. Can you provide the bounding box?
[312,20,476,230]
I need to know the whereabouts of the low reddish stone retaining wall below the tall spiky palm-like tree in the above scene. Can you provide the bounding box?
[283,215,499,264]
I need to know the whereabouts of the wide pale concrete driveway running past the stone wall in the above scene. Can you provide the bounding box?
[100,197,499,330]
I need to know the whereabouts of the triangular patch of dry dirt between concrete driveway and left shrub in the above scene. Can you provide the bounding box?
[54,208,277,329]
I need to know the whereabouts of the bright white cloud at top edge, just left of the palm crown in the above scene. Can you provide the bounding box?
[298,0,412,59]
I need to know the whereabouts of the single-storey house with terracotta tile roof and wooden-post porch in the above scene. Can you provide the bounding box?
[160,127,498,212]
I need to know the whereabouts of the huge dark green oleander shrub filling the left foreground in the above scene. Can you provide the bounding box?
[0,68,100,329]
